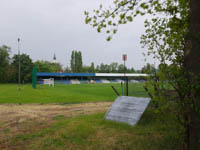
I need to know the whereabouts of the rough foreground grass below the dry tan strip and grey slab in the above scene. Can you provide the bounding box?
[8,106,180,150]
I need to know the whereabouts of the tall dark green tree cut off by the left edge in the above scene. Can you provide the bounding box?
[0,45,10,82]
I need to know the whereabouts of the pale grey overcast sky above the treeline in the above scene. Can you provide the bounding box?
[0,0,154,69]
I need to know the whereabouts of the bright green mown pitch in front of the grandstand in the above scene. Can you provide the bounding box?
[0,83,147,104]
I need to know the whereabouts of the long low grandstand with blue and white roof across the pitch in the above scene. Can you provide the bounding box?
[37,72,147,84]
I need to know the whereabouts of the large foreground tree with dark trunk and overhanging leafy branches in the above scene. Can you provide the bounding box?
[85,0,200,149]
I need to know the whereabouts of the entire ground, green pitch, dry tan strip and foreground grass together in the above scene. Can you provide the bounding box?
[0,83,180,150]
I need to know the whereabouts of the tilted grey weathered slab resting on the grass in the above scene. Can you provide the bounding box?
[105,96,150,126]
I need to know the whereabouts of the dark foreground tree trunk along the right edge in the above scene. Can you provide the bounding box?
[185,0,200,150]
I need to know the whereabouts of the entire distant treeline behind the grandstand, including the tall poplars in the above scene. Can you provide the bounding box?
[0,45,156,83]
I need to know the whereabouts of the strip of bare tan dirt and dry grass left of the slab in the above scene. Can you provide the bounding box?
[0,102,112,149]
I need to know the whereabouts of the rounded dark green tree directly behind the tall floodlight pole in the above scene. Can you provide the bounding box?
[12,54,33,82]
